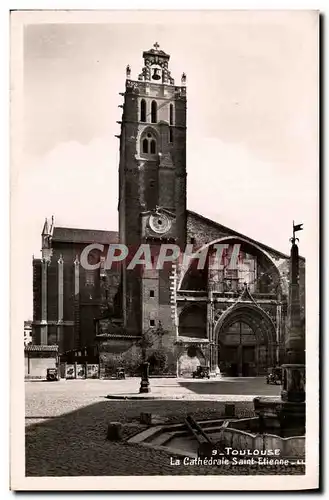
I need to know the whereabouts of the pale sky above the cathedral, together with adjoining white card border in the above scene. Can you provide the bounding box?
[11,11,318,318]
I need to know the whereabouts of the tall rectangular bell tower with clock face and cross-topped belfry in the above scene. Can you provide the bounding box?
[118,43,186,335]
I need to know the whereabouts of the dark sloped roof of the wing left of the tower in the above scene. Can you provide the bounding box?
[52,227,119,245]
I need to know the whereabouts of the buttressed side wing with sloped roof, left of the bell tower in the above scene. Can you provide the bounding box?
[32,227,120,353]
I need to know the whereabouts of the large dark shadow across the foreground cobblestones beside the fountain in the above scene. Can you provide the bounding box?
[26,400,253,476]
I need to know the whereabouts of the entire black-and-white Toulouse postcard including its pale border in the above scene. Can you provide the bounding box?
[11,10,320,491]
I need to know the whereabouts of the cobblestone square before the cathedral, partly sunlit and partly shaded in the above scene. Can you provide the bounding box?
[25,377,304,476]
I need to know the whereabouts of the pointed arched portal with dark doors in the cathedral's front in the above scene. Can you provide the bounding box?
[215,304,276,377]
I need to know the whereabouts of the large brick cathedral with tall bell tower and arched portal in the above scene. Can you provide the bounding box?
[32,43,305,377]
